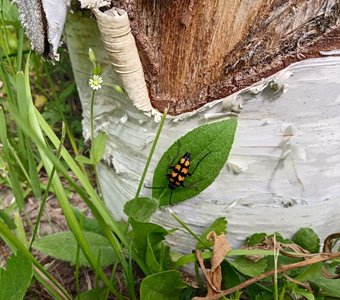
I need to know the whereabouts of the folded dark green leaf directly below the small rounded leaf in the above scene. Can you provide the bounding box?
[130,218,171,273]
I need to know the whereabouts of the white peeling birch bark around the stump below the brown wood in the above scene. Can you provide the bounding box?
[66,15,340,252]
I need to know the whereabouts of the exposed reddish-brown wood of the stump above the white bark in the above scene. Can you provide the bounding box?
[115,0,340,114]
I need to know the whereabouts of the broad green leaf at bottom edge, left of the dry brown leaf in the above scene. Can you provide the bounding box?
[140,270,187,300]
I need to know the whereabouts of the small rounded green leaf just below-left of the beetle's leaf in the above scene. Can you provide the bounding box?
[124,197,158,222]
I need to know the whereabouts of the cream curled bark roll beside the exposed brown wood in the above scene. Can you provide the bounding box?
[94,8,152,111]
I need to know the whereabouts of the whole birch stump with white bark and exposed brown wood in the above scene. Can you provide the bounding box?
[59,0,340,252]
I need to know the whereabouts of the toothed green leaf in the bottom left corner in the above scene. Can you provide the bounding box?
[0,251,32,300]
